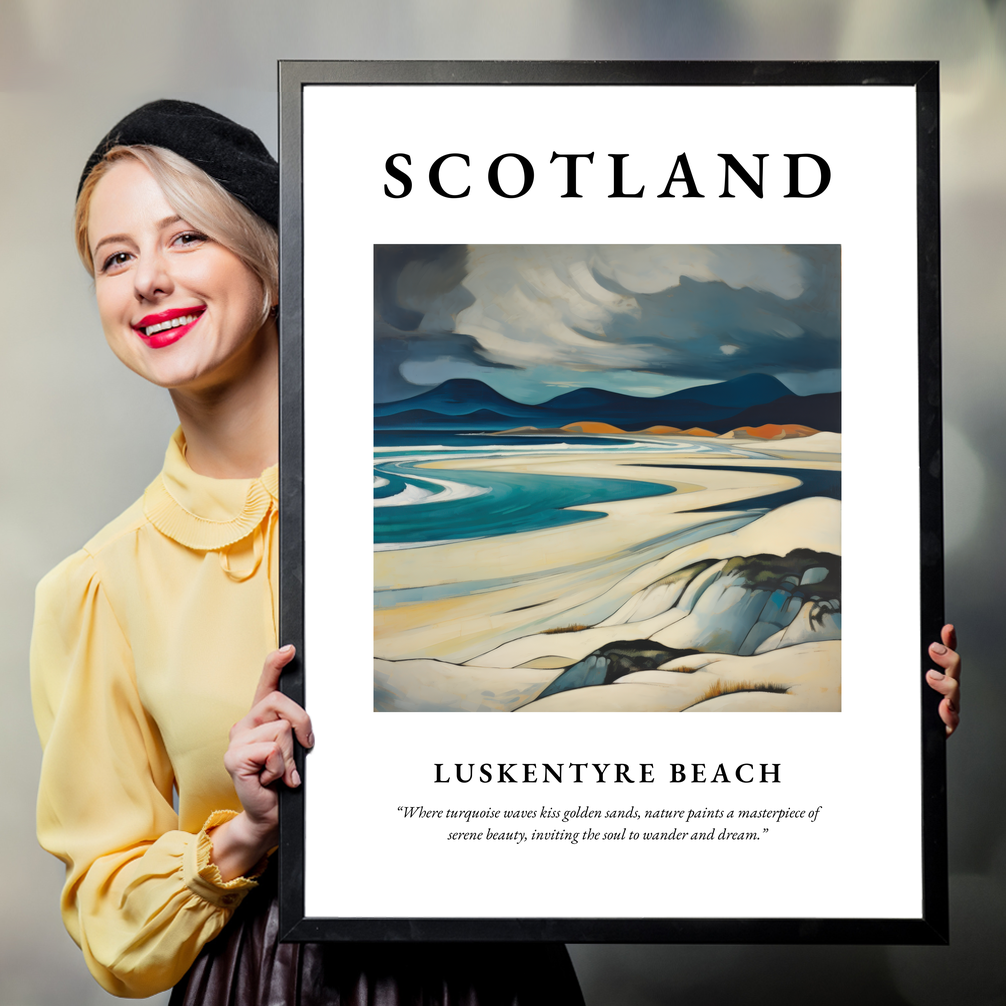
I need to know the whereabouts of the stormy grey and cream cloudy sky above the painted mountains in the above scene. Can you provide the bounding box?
[374,244,841,402]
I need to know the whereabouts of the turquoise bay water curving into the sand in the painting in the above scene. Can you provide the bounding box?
[374,461,674,544]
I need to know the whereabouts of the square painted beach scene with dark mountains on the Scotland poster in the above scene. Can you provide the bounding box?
[373,244,842,713]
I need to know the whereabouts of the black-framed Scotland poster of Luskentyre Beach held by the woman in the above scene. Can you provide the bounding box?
[281,62,947,943]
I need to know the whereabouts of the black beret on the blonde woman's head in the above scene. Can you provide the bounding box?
[76,99,280,227]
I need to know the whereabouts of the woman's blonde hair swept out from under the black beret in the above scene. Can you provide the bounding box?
[73,145,280,323]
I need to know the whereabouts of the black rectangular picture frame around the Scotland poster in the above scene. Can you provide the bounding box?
[279,61,949,944]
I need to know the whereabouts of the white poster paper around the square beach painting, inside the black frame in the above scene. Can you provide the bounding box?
[295,86,923,918]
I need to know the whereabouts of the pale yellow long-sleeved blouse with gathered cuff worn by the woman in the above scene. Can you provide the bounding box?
[31,431,278,997]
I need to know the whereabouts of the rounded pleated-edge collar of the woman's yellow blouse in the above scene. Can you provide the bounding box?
[143,427,280,551]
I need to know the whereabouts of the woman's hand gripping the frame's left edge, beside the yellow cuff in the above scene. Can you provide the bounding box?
[209,646,314,880]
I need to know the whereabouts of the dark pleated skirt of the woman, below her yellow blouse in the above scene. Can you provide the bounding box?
[170,870,583,1006]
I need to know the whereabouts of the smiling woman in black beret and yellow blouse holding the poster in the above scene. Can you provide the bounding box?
[32,102,582,1006]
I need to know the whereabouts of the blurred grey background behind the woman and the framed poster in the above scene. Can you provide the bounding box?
[0,0,1006,1006]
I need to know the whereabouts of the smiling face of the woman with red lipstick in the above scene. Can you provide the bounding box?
[88,158,265,392]
